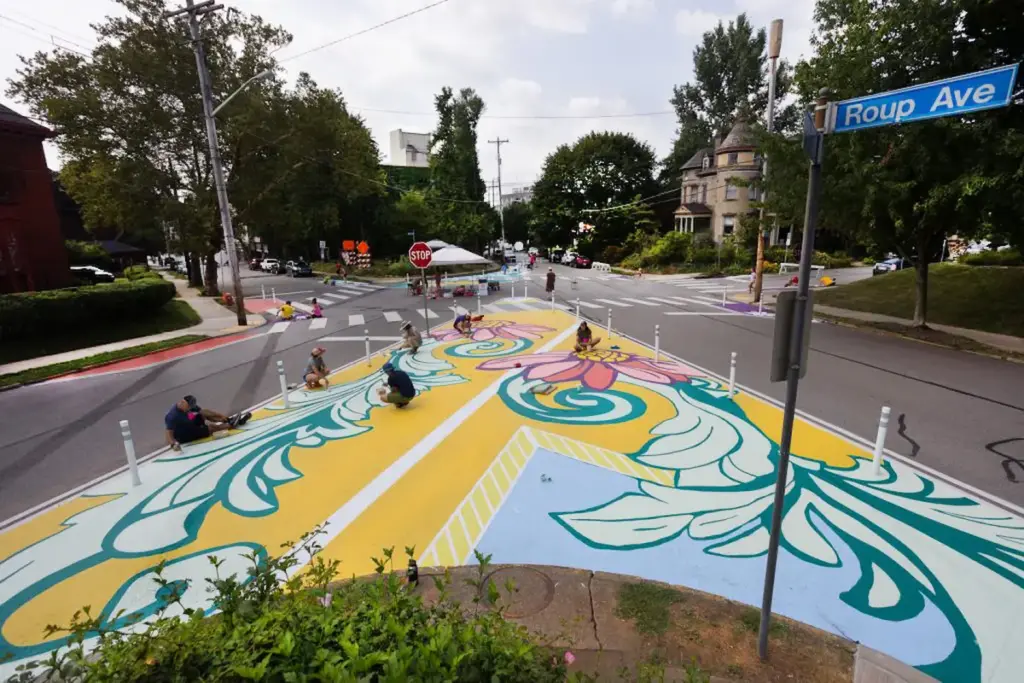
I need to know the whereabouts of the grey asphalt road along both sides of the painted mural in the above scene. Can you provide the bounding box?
[0,262,1024,520]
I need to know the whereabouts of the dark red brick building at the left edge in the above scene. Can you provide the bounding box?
[0,104,71,294]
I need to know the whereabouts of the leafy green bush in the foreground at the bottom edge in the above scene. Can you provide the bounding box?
[9,530,579,683]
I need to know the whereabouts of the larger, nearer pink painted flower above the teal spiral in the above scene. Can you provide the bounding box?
[479,349,698,391]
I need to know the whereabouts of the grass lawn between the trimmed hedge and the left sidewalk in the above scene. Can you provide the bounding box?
[0,299,203,364]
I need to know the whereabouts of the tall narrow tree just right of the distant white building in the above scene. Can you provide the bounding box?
[427,86,494,250]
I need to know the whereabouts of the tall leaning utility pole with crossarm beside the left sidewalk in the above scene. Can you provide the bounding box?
[164,0,249,326]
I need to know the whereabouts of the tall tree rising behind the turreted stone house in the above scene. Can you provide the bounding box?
[660,14,796,185]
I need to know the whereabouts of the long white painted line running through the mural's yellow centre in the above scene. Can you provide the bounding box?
[289,326,575,575]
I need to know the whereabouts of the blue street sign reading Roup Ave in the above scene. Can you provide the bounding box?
[826,65,1018,133]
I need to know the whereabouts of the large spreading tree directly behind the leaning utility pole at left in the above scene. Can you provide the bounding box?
[8,0,290,288]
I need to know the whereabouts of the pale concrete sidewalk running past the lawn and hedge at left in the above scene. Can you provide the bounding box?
[0,274,266,375]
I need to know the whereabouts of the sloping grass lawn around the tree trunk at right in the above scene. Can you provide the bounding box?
[814,263,1024,337]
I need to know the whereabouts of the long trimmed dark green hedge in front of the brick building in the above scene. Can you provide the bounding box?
[0,278,175,339]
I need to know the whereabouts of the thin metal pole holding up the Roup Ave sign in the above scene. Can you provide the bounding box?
[758,89,828,659]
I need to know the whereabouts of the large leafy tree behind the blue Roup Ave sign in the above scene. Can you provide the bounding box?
[766,0,1024,326]
